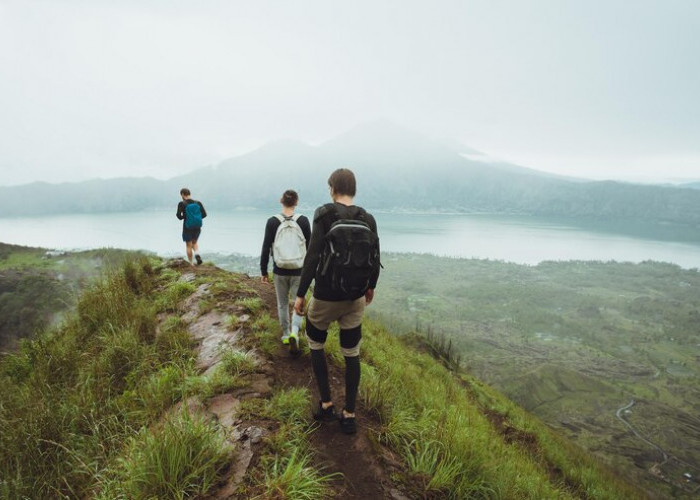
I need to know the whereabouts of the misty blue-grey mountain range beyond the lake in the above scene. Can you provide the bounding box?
[0,121,700,226]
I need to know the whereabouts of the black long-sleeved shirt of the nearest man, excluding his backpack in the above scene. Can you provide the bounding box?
[297,203,379,302]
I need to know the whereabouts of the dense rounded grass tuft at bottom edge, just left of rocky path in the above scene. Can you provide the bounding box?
[98,411,231,499]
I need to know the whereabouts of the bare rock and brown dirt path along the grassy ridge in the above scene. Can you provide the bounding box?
[170,266,408,500]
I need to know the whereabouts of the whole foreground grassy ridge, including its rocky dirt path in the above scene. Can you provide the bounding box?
[0,257,644,499]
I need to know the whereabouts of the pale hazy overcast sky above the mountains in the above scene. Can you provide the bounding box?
[0,0,700,185]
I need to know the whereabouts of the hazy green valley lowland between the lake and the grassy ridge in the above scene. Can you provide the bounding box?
[372,254,700,498]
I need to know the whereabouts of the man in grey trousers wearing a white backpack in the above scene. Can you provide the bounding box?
[260,189,311,356]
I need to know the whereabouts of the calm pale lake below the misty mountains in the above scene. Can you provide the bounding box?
[0,210,700,268]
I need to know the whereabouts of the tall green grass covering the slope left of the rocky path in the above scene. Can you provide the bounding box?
[0,259,227,498]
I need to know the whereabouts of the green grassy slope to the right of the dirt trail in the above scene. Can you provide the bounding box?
[360,322,640,499]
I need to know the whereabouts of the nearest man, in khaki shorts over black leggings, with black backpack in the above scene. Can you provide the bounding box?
[294,168,380,434]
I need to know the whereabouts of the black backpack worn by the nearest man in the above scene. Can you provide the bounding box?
[319,209,380,296]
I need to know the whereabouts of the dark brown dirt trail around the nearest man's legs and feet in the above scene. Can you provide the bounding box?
[249,280,408,500]
